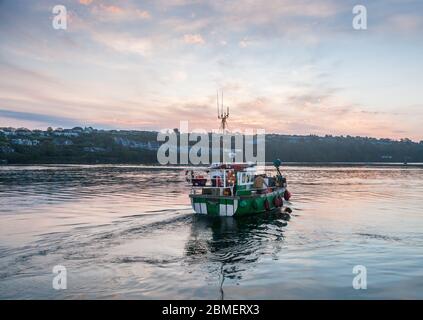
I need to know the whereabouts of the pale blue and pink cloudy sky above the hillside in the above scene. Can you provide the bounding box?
[0,0,423,141]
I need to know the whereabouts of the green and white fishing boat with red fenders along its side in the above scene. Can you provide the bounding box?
[186,159,291,216]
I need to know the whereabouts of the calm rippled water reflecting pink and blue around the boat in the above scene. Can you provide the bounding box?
[0,166,423,299]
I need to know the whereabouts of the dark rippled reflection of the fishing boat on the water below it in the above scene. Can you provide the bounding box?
[185,210,289,299]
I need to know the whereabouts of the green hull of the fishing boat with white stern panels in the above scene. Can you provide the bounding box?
[190,188,285,217]
